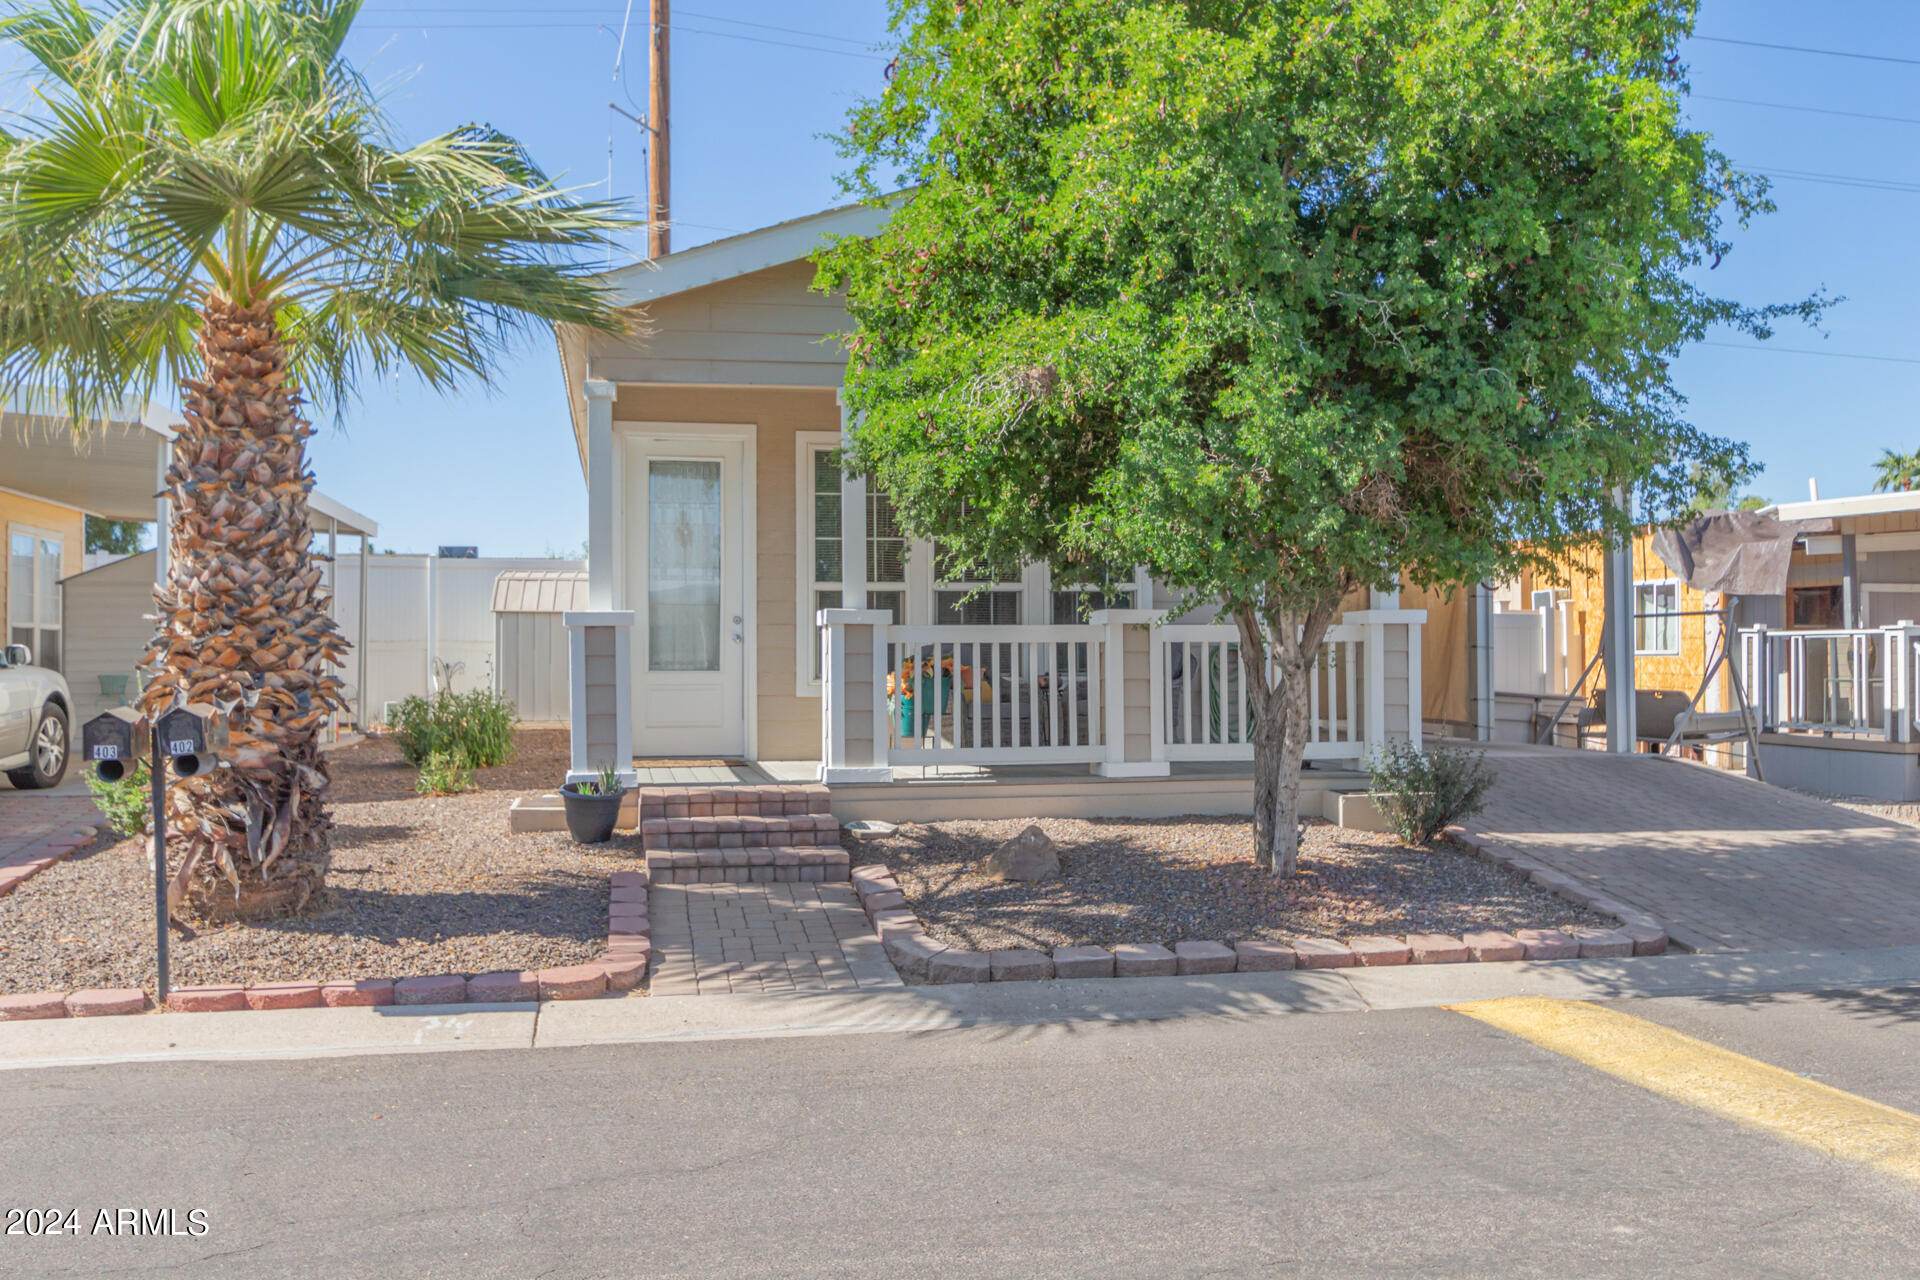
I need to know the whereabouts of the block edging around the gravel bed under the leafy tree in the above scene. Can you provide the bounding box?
[852,855,1667,983]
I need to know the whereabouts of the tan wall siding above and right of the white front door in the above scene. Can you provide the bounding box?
[614,379,839,760]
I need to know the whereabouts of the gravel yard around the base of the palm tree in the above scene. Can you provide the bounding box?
[0,729,639,994]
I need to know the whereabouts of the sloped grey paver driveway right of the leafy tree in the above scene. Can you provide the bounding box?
[1469,748,1920,950]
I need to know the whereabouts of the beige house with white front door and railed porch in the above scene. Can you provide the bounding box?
[559,205,1425,816]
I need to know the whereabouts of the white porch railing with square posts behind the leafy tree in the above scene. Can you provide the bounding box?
[820,608,1425,783]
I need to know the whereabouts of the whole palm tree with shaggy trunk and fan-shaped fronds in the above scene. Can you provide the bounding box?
[0,0,634,917]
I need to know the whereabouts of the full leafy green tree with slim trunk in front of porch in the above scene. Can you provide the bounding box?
[818,0,1822,873]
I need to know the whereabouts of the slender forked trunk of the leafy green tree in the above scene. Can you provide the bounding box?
[1233,606,1332,877]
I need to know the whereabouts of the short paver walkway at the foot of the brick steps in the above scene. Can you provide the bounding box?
[647,881,900,996]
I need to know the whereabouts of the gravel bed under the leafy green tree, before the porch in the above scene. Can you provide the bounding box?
[871,818,1615,950]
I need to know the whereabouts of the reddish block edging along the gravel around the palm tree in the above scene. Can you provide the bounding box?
[0,867,653,1023]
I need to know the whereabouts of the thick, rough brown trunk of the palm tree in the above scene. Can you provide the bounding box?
[142,297,348,919]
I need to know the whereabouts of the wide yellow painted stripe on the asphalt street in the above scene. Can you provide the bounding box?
[1446,996,1920,1182]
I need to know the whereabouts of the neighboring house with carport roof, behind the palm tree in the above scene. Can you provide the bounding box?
[0,405,378,722]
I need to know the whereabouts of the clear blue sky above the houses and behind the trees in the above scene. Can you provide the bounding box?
[15,0,1920,555]
